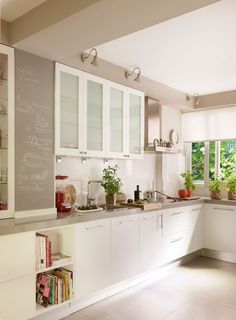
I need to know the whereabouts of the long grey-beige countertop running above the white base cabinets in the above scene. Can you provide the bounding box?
[0,198,236,235]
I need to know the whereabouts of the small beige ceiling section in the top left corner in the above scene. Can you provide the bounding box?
[0,0,46,22]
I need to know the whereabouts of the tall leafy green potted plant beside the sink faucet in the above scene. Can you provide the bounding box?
[102,165,122,204]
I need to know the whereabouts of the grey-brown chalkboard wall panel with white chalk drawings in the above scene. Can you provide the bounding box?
[15,49,54,211]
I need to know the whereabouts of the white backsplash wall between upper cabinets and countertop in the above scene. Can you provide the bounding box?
[56,154,184,204]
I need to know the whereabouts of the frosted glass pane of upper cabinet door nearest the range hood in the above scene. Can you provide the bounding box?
[128,93,143,155]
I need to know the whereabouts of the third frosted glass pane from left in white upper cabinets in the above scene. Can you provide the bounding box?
[108,87,125,154]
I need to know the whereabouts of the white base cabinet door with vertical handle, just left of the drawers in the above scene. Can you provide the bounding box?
[139,211,162,272]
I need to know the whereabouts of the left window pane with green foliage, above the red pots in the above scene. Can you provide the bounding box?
[192,142,205,182]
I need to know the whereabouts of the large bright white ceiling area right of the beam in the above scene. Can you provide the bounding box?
[97,0,236,94]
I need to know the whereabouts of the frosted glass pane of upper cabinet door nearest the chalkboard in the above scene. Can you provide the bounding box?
[60,72,80,149]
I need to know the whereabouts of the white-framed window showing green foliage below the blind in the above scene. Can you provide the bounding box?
[185,140,236,185]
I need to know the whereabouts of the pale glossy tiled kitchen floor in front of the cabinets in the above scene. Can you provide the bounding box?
[64,258,236,320]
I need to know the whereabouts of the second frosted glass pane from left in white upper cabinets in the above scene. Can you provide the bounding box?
[85,76,104,154]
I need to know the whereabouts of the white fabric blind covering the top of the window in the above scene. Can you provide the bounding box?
[182,106,236,142]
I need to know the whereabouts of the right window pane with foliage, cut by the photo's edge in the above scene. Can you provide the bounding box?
[220,140,236,180]
